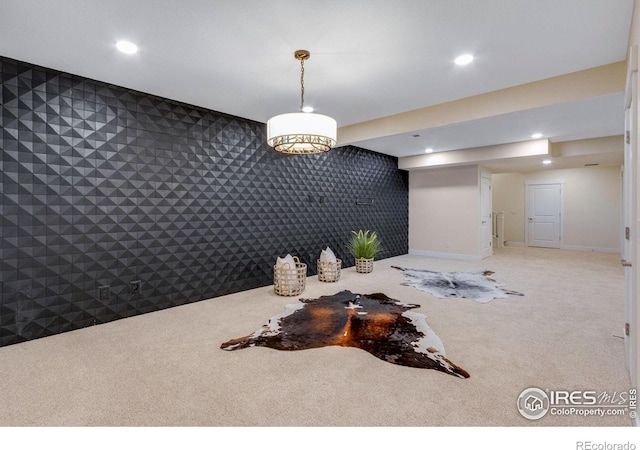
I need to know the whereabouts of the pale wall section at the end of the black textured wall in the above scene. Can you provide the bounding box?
[409,166,480,259]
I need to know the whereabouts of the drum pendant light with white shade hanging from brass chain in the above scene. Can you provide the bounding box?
[267,50,337,155]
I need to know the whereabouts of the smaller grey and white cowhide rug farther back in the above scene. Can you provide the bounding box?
[392,266,524,303]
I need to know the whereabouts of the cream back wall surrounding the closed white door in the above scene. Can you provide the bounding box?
[493,166,622,252]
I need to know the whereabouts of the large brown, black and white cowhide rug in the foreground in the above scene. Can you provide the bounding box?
[220,291,469,378]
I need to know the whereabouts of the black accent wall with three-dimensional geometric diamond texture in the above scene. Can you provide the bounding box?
[0,57,408,346]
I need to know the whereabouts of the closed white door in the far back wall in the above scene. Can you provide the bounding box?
[527,183,562,248]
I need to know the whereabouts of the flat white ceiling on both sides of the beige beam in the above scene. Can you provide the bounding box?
[0,0,633,171]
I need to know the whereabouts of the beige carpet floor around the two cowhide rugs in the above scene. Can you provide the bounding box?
[0,248,631,427]
